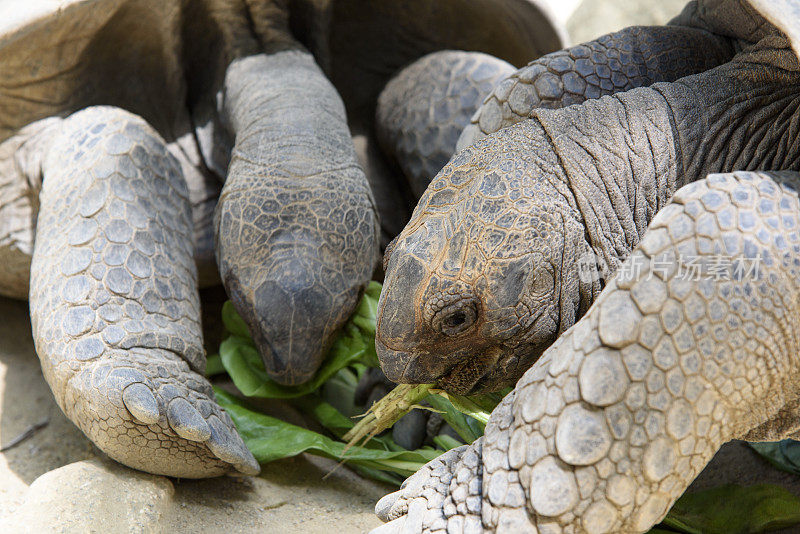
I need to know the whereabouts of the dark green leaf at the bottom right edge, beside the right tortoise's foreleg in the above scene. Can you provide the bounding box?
[661,484,800,534]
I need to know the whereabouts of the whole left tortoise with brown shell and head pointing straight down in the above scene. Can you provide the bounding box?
[0,0,561,477]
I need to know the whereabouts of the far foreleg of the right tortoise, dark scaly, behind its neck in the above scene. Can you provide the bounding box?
[457,26,734,150]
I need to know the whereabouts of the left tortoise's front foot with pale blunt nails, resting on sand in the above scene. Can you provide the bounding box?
[64,348,259,478]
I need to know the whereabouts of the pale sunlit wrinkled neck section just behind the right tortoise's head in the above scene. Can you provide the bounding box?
[535,88,681,278]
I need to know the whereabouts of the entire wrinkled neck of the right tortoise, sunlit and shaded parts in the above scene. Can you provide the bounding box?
[536,35,800,284]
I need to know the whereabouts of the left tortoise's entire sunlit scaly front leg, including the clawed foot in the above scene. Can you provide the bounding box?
[30,107,259,478]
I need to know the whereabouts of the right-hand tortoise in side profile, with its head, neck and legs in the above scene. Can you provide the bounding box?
[376,0,800,533]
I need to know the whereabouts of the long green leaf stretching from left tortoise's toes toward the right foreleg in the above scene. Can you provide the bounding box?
[214,388,442,477]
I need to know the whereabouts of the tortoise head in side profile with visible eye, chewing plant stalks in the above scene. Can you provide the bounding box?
[376,129,598,394]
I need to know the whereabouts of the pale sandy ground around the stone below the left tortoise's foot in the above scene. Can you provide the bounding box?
[0,299,393,533]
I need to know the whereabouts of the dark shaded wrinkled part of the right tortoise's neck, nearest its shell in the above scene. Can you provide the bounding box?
[653,46,800,193]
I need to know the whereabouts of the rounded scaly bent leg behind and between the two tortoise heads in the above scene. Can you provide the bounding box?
[375,50,514,198]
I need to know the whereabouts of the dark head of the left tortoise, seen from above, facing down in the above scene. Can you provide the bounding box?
[217,174,378,385]
